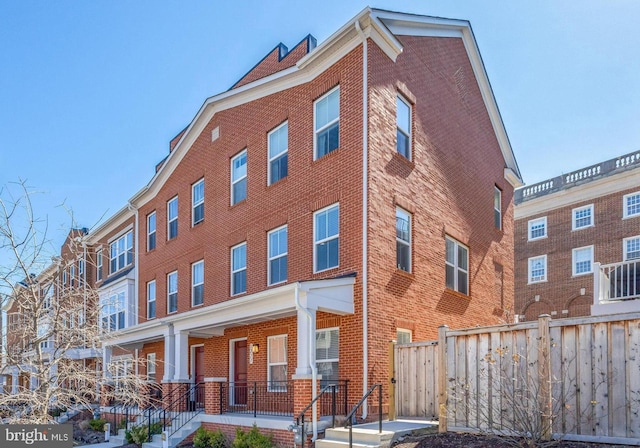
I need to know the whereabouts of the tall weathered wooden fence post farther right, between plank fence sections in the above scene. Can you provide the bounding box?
[538,314,552,440]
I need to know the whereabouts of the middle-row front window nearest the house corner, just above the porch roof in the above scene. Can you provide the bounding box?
[313,204,340,272]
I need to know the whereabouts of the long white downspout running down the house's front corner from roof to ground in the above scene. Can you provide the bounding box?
[355,20,369,419]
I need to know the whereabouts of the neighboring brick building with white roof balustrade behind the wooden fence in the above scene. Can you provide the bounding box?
[515,153,640,320]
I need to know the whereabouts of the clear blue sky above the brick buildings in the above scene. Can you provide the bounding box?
[0,0,640,251]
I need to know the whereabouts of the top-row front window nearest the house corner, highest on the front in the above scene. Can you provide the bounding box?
[314,87,340,160]
